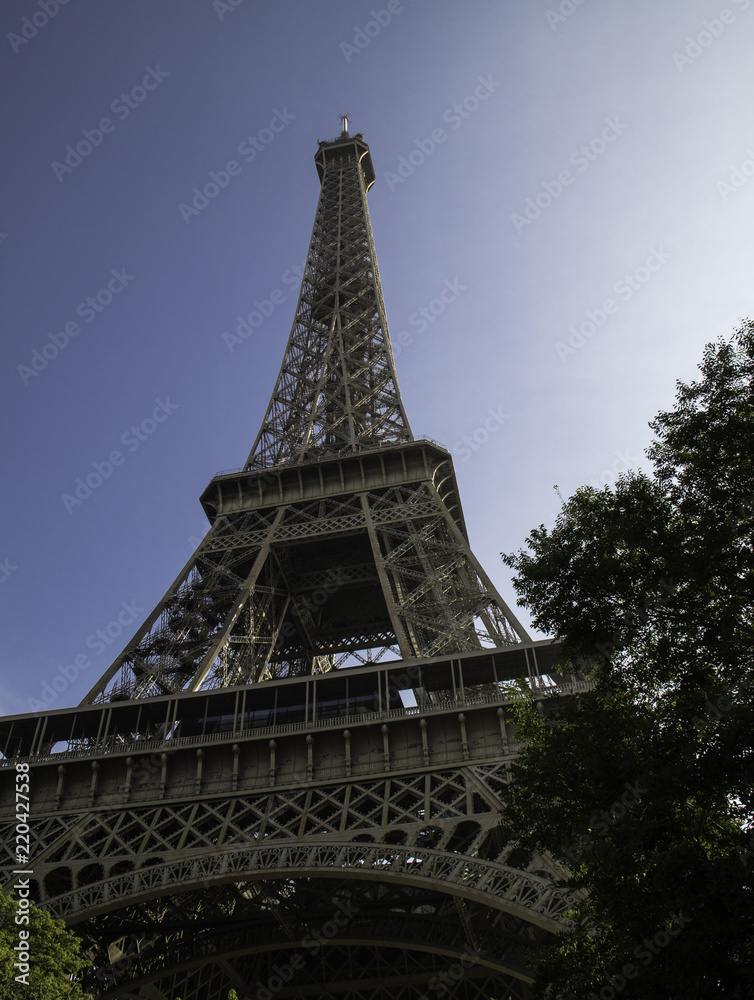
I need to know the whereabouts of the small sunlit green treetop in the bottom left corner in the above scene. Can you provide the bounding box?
[0,892,89,1000]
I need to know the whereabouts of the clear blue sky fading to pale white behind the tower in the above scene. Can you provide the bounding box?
[0,0,754,714]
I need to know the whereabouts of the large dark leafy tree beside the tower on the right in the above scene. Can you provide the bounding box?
[503,322,754,1000]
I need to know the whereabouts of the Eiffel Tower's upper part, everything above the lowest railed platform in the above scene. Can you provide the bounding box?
[81,134,528,702]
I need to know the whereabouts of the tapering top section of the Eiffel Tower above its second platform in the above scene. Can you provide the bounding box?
[246,131,412,469]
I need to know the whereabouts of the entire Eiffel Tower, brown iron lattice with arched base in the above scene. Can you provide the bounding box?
[0,117,574,1000]
